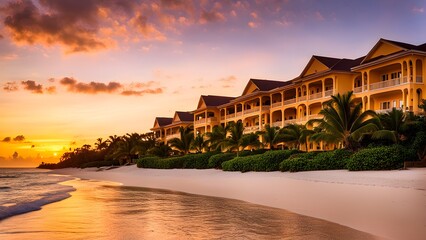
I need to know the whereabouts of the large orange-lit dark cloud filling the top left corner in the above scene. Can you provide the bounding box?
[4,0,109,52]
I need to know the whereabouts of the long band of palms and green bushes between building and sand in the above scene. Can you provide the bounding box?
[40,92,426,172]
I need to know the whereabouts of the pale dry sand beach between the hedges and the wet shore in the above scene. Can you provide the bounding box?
[54,166,426,239]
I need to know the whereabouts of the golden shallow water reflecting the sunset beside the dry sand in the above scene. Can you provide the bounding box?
[0,171,377,240]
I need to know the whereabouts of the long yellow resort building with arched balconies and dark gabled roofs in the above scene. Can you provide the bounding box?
[152,39,426,150]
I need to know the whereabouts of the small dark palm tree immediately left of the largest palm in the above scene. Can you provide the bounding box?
[280,124,313,151]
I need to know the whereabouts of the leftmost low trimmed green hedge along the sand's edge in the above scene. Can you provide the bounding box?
[137,152,217,169]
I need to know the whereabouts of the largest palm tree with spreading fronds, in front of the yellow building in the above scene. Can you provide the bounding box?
[308,91,381,149]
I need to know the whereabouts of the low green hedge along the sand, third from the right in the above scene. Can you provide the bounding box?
[222,150,296,172]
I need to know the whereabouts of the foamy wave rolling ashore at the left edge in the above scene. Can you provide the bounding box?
[0,186,75,220]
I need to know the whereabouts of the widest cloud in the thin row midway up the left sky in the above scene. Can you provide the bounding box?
[59,77,123,94]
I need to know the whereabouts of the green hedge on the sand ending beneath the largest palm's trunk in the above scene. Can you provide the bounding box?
[280,149,352,172]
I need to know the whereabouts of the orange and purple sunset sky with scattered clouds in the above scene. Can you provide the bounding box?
[0,0,426,167]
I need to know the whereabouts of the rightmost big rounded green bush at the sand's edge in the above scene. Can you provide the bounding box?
[347,145,412,171]
